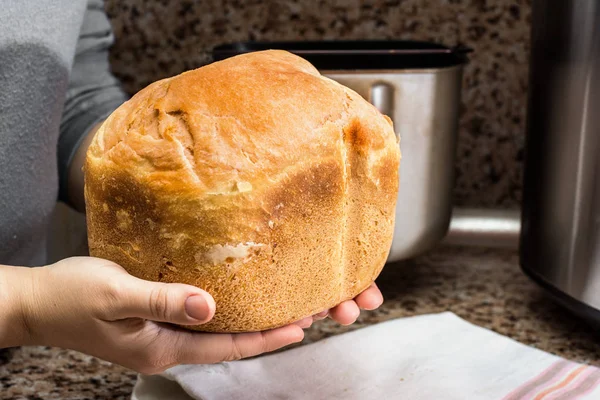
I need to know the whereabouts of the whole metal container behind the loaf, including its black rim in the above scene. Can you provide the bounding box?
[213,41,466,262]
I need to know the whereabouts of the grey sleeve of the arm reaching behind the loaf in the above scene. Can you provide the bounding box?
[57,0,127,202]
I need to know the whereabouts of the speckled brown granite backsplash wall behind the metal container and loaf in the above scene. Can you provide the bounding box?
[106,0,531,207]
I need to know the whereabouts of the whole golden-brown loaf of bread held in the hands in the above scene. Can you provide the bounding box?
[84,50,400,332]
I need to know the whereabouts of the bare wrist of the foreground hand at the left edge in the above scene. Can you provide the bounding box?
[0,265,37,348]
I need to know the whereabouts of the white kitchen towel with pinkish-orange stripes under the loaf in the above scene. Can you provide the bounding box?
[132,313,600,400]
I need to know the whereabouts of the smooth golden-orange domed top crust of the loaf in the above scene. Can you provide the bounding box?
[89,50,396,195]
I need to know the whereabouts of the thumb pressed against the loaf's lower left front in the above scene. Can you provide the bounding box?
[112,277,215,325]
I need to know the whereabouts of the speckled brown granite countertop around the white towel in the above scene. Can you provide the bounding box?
[0,247,600,399]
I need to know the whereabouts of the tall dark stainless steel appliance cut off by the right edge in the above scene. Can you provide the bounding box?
[520,0,600,321]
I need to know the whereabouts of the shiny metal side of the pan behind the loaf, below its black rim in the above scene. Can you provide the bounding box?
[322,66,462,261]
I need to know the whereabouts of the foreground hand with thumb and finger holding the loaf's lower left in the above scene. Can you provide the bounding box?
[20,257,312,374]
